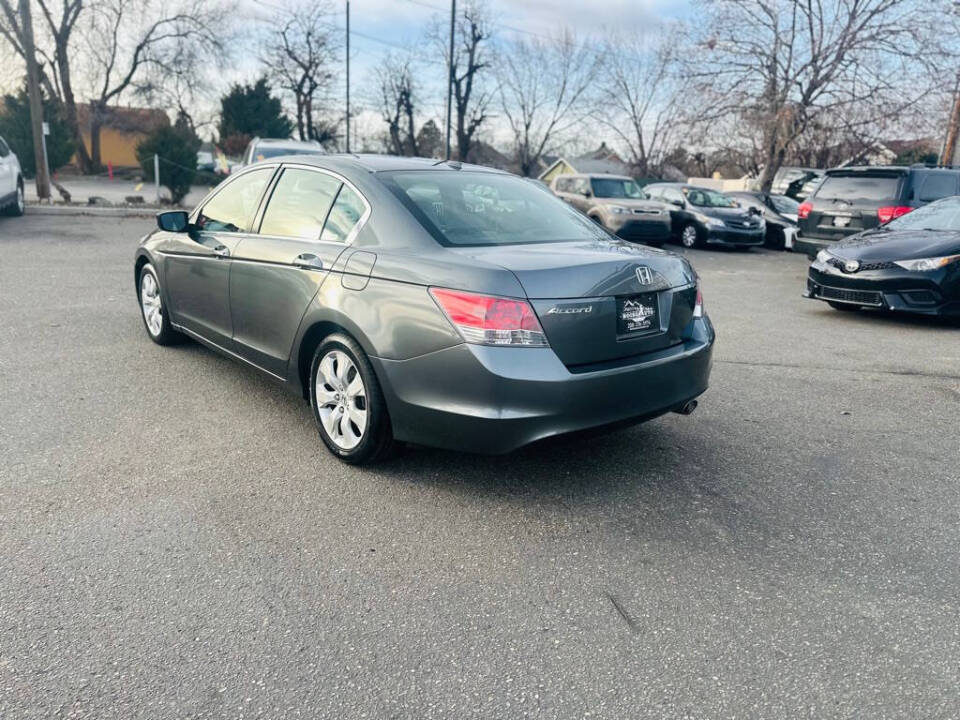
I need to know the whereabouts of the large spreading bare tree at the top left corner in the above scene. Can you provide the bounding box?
[0,0,231,172]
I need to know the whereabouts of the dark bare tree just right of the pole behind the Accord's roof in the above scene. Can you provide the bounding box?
[436,0,496,161]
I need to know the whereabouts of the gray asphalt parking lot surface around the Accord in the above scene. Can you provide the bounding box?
[0,216,960,718]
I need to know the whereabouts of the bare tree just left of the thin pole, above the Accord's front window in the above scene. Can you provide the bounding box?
[263,0,340,140]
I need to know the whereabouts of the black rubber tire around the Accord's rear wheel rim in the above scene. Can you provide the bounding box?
[310,333,395,465]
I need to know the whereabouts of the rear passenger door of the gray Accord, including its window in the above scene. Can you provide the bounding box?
[230,165,370,378]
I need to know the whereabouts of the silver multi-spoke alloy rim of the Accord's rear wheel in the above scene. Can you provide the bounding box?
[314,350,368,450]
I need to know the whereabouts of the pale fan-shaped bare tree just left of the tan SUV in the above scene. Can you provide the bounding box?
[497,31,599,177]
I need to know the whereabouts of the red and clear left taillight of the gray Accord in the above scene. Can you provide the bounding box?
[430,288,548,347]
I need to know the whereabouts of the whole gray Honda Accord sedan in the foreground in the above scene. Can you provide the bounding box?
[134,155,714,463]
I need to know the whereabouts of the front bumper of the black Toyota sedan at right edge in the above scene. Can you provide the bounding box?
[804,262,960,316]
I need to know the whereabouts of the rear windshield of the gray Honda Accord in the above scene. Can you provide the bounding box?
[380,170,610,246]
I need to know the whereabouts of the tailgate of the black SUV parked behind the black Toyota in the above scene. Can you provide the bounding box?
[801,169,906,240]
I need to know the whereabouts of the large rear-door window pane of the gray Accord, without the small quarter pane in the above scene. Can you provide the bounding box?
[260,168,342,240]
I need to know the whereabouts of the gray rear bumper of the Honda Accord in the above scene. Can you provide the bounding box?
[371,318,714,453]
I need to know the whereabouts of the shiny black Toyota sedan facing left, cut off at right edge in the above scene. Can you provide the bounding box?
[805,196,960,317]
